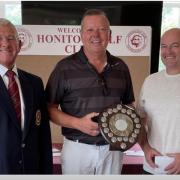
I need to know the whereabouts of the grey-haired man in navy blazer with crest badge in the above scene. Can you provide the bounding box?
[0,18,52,174]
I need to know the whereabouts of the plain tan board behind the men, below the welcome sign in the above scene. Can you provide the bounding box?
[17,55,150,143]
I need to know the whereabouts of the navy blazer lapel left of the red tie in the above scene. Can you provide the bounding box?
[0,76,21,135]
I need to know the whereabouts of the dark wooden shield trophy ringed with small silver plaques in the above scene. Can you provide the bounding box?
[99,104,141,151]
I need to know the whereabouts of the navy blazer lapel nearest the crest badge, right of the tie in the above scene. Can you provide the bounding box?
[18,70,33,140]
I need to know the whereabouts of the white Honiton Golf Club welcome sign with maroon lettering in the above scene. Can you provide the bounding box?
[16,25,151,56]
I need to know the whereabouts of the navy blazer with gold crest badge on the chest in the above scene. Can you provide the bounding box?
[0,69,52,174]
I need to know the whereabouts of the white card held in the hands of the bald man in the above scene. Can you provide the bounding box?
[155,156,174,174]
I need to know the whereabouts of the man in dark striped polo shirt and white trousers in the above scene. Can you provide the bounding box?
[46,9,134,174]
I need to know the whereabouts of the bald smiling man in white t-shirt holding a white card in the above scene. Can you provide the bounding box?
[137,28,180,174]
